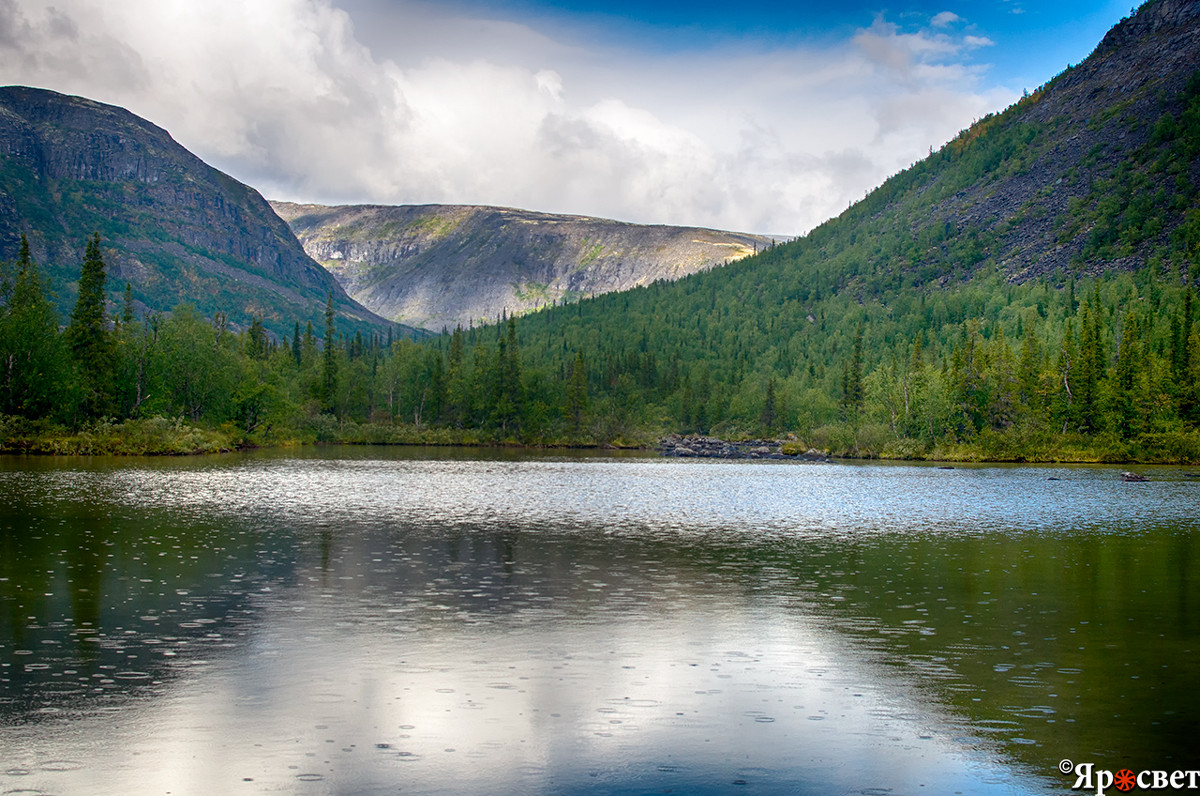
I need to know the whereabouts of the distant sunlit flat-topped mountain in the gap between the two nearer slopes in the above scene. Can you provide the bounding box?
[271,202,773,330]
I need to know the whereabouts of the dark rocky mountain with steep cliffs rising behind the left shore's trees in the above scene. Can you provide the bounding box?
[0,86,403,334]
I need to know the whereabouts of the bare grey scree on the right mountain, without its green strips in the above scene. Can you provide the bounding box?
[913,0,1200,281]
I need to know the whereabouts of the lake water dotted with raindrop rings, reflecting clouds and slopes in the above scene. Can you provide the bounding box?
[0,448,1200,795]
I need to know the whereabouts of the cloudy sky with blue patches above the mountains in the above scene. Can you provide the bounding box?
[0,0,1132,235]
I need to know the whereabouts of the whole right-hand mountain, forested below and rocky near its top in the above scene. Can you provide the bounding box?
[448,0,1200,449]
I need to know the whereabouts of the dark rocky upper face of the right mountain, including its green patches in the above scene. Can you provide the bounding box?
[902,0,1200,280]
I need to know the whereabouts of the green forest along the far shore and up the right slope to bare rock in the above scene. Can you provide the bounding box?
[7,69,1200,462]
